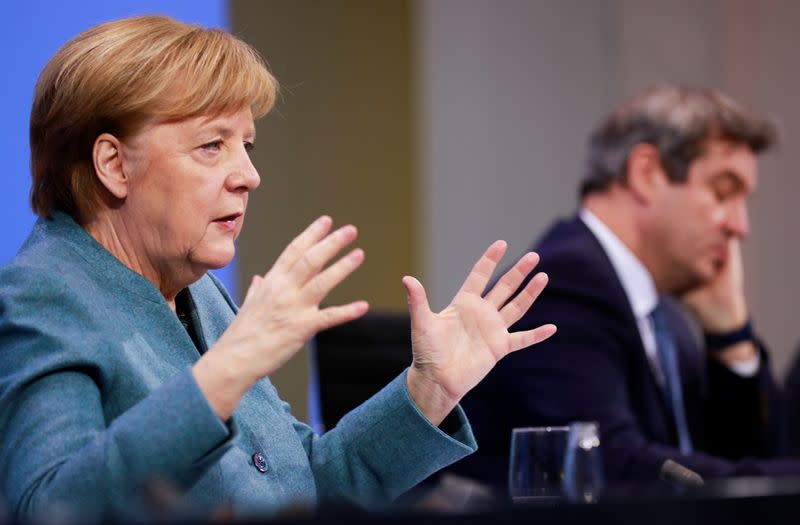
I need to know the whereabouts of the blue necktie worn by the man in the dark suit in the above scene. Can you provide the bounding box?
[650,301,692,454]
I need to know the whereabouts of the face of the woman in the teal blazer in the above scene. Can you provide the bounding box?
[120,108,260,280]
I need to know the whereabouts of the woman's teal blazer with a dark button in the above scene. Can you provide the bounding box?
[0,213,477,517]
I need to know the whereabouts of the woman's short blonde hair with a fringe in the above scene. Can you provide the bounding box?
[30,16,278,219]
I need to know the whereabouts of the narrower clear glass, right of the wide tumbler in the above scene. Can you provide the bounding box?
[562,422,605,503]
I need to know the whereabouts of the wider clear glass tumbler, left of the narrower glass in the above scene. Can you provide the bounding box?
[508,427,569,504]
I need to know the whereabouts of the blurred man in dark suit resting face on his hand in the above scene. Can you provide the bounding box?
[459,86,800,485]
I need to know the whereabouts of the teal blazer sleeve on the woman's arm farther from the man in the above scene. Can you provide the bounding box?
[0,276,234,517]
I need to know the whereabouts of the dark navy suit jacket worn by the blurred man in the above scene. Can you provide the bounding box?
[457,213,800,486]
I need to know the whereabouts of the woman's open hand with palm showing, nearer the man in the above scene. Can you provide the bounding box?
[403,241,556,426]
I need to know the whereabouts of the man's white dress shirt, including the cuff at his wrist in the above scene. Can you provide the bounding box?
[579,208,761,376]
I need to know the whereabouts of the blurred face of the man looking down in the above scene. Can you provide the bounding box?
[651,139,758,293]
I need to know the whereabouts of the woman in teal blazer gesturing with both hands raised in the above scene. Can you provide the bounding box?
[0,17,555,516]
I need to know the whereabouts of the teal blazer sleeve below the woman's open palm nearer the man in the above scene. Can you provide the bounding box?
[276,371,477,507]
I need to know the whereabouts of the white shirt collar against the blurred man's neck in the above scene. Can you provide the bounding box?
[579,208,658,319]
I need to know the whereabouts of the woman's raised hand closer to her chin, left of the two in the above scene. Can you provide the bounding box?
[193,216,368,421]
